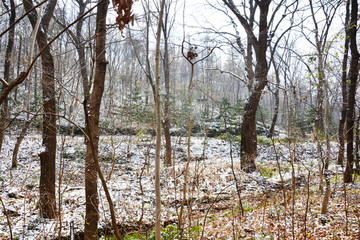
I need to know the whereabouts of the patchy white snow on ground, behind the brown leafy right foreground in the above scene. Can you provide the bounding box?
[0,135,356,239]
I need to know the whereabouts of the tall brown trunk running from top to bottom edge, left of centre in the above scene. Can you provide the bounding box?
[84,0,109,240]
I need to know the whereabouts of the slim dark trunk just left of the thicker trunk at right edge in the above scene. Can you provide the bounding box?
[337,1,350,166]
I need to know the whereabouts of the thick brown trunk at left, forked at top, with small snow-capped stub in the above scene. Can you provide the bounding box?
[24,0,56,218]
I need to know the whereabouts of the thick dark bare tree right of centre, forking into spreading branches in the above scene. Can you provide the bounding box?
[223,0,292,172]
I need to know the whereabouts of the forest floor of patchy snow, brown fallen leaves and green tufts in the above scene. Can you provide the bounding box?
[0,134,360,239]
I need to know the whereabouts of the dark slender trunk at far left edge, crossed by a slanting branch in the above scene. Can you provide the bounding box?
[0,0,16,152]
